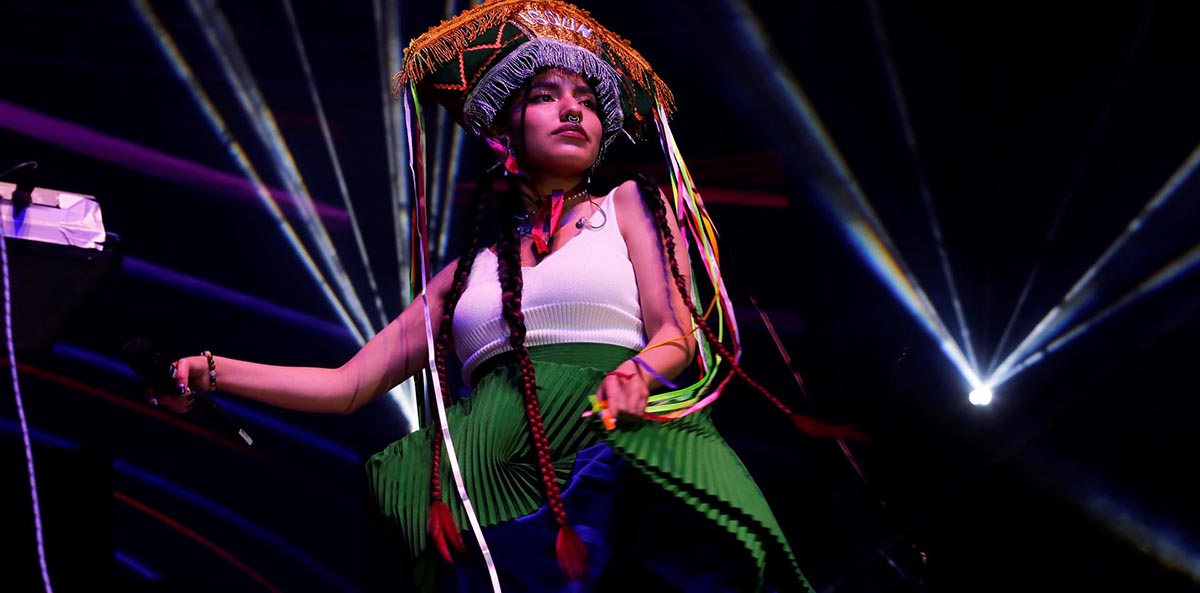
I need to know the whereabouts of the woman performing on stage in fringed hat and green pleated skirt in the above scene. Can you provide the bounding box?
[158,0,830,591]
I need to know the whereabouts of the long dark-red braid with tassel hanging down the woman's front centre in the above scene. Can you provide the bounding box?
[498,198,588,581]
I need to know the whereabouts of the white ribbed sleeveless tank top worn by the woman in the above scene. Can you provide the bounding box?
[454,190,646,382]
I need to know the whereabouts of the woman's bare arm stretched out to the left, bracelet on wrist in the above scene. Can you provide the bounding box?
[158,263,455,414]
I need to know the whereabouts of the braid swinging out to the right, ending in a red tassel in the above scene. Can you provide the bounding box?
[638,175,868,441]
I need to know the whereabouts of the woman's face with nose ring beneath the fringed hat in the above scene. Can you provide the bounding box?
[509,68,604,176]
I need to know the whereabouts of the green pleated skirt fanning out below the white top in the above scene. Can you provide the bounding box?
[366,343,812,592]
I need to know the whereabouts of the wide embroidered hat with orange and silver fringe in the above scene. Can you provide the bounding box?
[392,0,674,145]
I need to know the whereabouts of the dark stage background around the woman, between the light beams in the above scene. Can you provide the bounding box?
[0,0,1200,593]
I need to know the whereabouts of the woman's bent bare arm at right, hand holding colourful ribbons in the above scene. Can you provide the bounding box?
[596,181,696,418]
